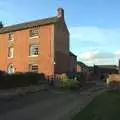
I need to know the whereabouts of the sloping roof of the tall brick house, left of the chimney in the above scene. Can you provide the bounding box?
[0,16,59,34]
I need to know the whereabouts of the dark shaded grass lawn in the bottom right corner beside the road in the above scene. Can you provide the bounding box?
[72,92,120,120]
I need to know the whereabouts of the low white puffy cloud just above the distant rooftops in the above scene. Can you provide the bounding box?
[77,51,118,65]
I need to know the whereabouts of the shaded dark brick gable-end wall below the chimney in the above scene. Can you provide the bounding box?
[54,19,69,73]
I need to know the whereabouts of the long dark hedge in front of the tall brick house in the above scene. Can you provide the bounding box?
[0,72,45,89]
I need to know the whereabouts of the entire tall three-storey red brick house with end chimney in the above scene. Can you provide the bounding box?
[0,8,76,75]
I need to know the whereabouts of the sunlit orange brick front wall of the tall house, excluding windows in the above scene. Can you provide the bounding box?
[0,25,54,75]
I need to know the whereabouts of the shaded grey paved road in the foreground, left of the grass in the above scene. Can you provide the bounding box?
[0,84,104,120]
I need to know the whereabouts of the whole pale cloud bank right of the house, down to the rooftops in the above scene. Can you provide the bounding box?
[70,26,120,64]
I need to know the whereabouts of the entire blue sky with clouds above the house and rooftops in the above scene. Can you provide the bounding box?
[0,0,120,66]
